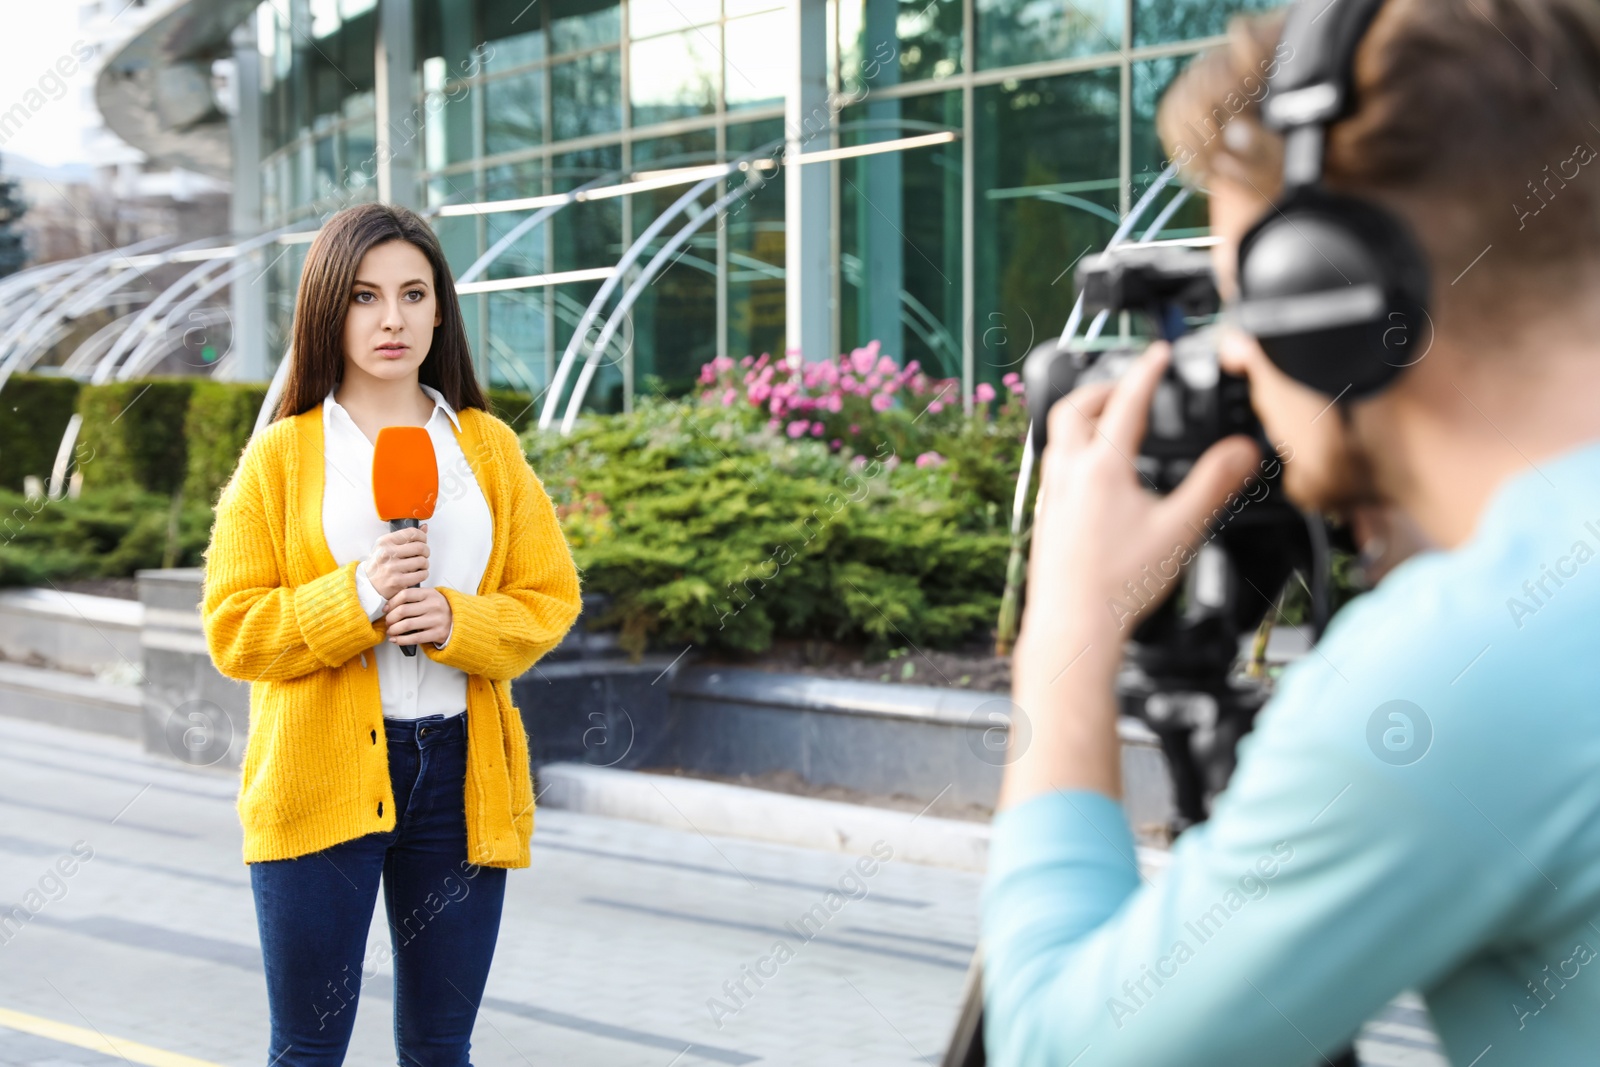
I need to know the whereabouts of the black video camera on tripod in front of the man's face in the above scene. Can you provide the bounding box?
[1022,245,1330,833]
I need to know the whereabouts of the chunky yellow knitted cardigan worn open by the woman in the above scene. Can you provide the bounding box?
[200,403,581,867]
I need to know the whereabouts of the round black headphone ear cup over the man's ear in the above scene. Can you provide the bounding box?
[1238,189,1432,398]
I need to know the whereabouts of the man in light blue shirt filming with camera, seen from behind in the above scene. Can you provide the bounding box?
[982,0,1600,1067]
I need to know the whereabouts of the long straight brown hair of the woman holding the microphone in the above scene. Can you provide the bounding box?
[272,203,488,421]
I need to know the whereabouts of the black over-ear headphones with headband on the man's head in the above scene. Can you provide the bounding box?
[1235,0,1432,400]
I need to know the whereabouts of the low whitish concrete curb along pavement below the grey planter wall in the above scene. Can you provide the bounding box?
[536,763,1166,873]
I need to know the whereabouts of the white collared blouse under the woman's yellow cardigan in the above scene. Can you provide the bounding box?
[322,382,494,718]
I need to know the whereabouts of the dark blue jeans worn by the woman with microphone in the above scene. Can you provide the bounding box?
[250,712,506,1067]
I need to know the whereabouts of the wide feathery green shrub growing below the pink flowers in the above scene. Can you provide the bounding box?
[523,397,1010,654]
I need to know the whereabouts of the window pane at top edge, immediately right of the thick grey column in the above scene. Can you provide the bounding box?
[838,0,962,91]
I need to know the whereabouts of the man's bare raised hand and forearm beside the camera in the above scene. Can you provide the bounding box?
[998,342,1258,808]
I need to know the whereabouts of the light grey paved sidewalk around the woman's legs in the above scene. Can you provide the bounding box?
[0,718,979,1067]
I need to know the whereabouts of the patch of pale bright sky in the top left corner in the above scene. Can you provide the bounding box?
[0,0,104,166]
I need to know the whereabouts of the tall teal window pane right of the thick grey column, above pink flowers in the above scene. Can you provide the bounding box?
[838,93,962,376]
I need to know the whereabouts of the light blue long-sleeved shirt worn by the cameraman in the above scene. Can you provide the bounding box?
[982,443,1600,1067]
